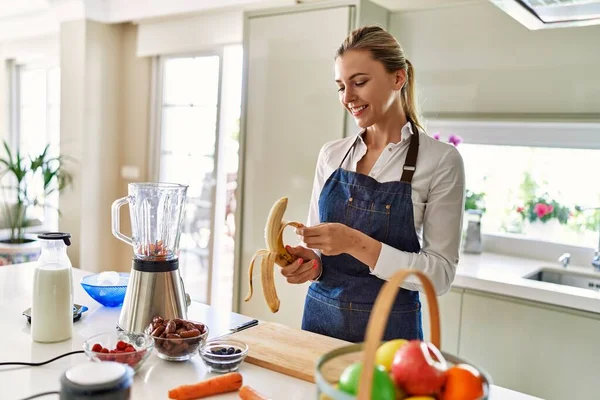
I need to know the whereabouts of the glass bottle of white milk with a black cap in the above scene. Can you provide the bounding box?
[31,232,73,342]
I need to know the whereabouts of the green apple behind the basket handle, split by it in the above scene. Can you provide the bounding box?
[339,362,396,400]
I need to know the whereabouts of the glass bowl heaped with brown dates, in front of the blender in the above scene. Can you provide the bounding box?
[146,316,208,361]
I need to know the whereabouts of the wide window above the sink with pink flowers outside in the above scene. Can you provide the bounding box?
[428,120,600,252]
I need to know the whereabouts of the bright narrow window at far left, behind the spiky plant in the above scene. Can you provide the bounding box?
[11,65,60,230]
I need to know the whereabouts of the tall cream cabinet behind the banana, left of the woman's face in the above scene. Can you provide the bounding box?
[234,1,388,328]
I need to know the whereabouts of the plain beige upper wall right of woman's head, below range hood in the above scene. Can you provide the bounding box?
[390,1,600,115]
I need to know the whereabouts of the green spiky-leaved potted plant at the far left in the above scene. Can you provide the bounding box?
[0,141,73,265]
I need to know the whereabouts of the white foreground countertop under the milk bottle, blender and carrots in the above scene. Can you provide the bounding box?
[0,263,535,400]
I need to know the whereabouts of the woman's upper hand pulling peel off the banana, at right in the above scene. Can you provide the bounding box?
[296,222,356,256]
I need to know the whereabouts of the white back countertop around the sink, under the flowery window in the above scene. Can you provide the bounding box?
[452,253,600,313]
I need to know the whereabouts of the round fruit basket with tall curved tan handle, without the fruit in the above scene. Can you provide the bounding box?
[315,269,492,400]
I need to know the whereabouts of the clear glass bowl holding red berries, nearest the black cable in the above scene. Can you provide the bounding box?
[83,331,154,372]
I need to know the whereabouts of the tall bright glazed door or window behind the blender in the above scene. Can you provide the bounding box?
[156,45,242,311]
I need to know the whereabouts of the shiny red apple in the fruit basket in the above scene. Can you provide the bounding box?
[392,340,448,396]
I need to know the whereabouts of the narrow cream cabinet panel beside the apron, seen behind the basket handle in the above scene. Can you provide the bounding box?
[420,288,464,354]
